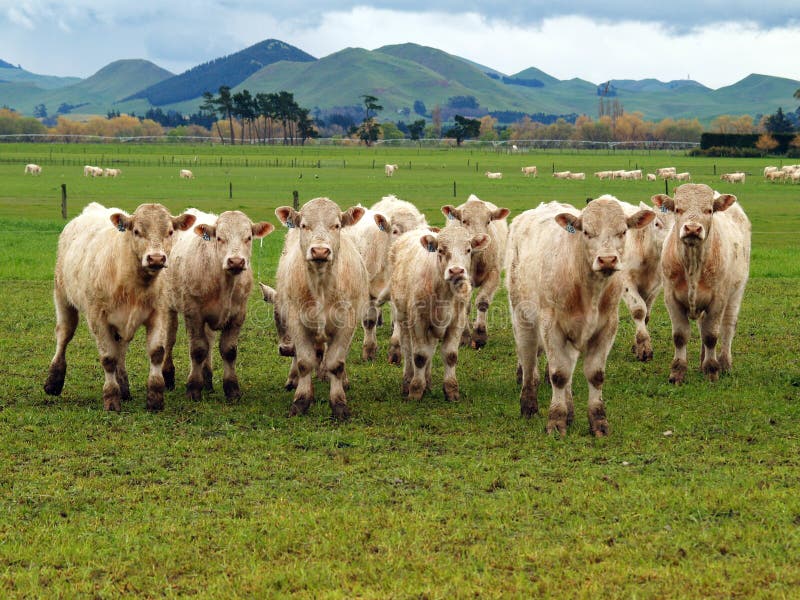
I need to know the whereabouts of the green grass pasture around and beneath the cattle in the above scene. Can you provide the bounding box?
[0,144,800,598]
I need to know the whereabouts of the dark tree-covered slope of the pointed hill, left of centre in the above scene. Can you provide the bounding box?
[126,40,316,106]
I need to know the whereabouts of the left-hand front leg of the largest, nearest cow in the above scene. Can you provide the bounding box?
[543,331,579,436]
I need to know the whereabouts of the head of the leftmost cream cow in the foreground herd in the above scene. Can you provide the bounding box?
[110,204,196,273]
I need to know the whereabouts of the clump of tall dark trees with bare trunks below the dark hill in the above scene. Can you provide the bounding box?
[200,85,318,145]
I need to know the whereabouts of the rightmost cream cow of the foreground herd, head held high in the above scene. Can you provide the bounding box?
[652,184,751,384]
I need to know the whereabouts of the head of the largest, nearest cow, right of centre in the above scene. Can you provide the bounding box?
[555,198,656,277]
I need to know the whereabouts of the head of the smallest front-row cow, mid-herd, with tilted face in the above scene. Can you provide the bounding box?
[419,227,489,297]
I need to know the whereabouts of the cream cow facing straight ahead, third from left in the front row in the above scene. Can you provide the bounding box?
[275,198,369,420]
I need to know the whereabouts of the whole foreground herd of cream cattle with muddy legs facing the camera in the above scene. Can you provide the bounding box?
[44,171,750,436]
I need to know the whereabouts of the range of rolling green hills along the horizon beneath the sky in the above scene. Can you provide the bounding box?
[0,40,800,124]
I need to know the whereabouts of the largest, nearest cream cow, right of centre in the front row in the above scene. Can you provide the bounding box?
[506,199,655,437]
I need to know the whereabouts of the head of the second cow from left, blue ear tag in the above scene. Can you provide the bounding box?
[194,210,275,275]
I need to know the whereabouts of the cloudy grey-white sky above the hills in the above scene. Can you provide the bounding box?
[0,0,800,88]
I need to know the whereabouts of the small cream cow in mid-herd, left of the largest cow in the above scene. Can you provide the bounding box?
[391,224,490,401]
